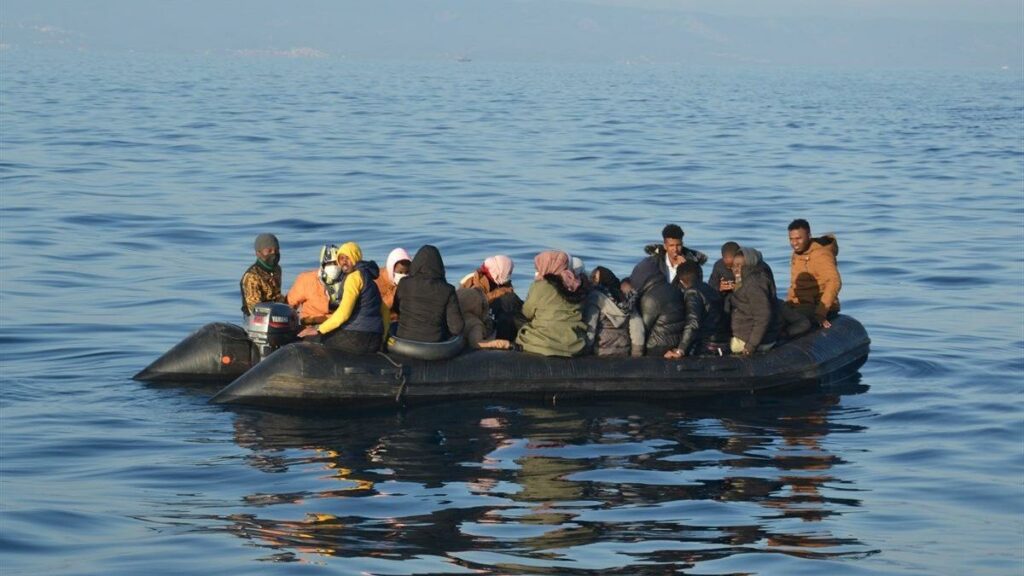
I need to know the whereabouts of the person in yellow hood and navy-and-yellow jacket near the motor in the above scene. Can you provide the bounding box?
[299,242,388,354]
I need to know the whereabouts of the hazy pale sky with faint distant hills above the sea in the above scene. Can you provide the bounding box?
[0,0,1024,69]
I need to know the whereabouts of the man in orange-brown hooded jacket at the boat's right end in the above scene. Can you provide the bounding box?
[785,218,843,328]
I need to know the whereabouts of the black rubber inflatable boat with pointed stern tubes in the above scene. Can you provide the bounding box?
[135,309,870,408]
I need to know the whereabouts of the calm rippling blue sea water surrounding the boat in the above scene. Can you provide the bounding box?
[0,50,1024,574]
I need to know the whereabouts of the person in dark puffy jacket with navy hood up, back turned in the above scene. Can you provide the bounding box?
[630,256,685,357]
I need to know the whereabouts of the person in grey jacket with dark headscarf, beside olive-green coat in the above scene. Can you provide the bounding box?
[573,266,644,357]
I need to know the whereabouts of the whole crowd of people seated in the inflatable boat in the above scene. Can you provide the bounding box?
[240,219,842,359]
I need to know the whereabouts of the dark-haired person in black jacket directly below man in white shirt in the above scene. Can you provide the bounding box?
[665,261,722,359]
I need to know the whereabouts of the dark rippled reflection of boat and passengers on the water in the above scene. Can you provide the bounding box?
[191,384,876,573]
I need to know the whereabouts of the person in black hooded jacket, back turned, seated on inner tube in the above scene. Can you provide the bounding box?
[391,244,463,342]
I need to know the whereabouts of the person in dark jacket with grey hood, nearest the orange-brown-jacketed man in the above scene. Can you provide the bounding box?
[725,248,781,356]
